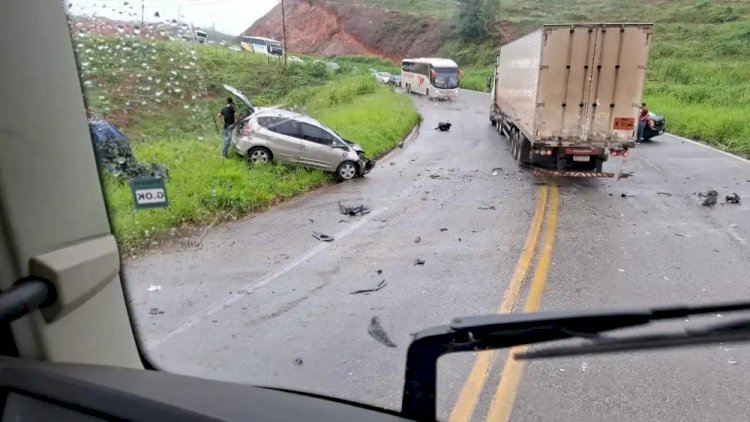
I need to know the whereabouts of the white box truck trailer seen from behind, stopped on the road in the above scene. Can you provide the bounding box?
[490,23,653,177]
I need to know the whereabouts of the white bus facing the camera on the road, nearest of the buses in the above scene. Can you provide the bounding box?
[401,58,463,99]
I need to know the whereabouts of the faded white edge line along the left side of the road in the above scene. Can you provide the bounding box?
[143,208,388,351]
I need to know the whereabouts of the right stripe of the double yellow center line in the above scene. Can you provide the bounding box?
[487,186,560,422]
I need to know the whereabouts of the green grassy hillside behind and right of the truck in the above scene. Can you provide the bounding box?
[434,0,750,156]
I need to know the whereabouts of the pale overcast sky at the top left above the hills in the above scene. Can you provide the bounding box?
[69,0,279,35]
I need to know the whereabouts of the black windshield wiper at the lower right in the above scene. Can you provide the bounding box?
[401,302,750,420]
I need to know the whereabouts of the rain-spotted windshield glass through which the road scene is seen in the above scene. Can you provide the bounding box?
[60,0,750,421]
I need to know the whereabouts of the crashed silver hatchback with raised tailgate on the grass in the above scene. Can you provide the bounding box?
[224,85,375,180]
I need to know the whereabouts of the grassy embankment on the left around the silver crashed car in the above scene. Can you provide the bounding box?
[75,37,419,251]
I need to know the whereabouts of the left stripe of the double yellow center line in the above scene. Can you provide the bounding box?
[449,186,548,422]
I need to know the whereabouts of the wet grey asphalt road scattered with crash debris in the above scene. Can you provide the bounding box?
[124,91,750,421]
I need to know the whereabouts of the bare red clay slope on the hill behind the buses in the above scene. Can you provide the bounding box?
[243,0,449,62]
